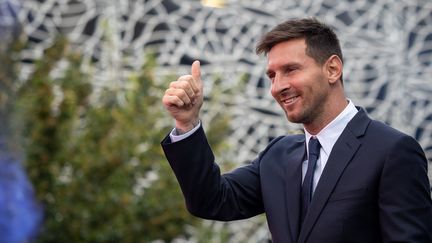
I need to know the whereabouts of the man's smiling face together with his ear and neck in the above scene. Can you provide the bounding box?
[267,38,348,134]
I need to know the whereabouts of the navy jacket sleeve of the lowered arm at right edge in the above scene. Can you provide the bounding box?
[379,136,432,243]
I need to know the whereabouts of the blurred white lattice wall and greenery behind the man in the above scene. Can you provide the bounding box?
[0,0,432,243]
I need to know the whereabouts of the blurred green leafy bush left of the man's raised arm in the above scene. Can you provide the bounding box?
[2,38,228,242]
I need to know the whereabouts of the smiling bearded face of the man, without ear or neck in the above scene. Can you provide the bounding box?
[267,39,330,125]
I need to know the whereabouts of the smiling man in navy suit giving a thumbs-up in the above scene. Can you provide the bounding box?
[162,18,432,243]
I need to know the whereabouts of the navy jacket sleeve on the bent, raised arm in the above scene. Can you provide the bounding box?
[161,127,264,221]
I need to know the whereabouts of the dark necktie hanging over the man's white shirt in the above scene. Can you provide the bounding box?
[301,137,321,222]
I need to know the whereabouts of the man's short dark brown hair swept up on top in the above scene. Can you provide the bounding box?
[256,18,343,65]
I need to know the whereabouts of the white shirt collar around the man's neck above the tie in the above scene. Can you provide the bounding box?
[304,99,358,156]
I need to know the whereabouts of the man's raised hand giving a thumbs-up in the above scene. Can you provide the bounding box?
[162,61,204,133]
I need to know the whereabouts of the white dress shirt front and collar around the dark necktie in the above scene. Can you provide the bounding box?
[302,100,358,192]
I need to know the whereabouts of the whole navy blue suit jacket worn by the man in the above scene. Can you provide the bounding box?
[162,109,432,243]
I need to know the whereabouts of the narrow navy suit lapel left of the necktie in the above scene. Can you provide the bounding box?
[285,136,306,242]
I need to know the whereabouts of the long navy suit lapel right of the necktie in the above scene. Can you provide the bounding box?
[298,109,370,243]
